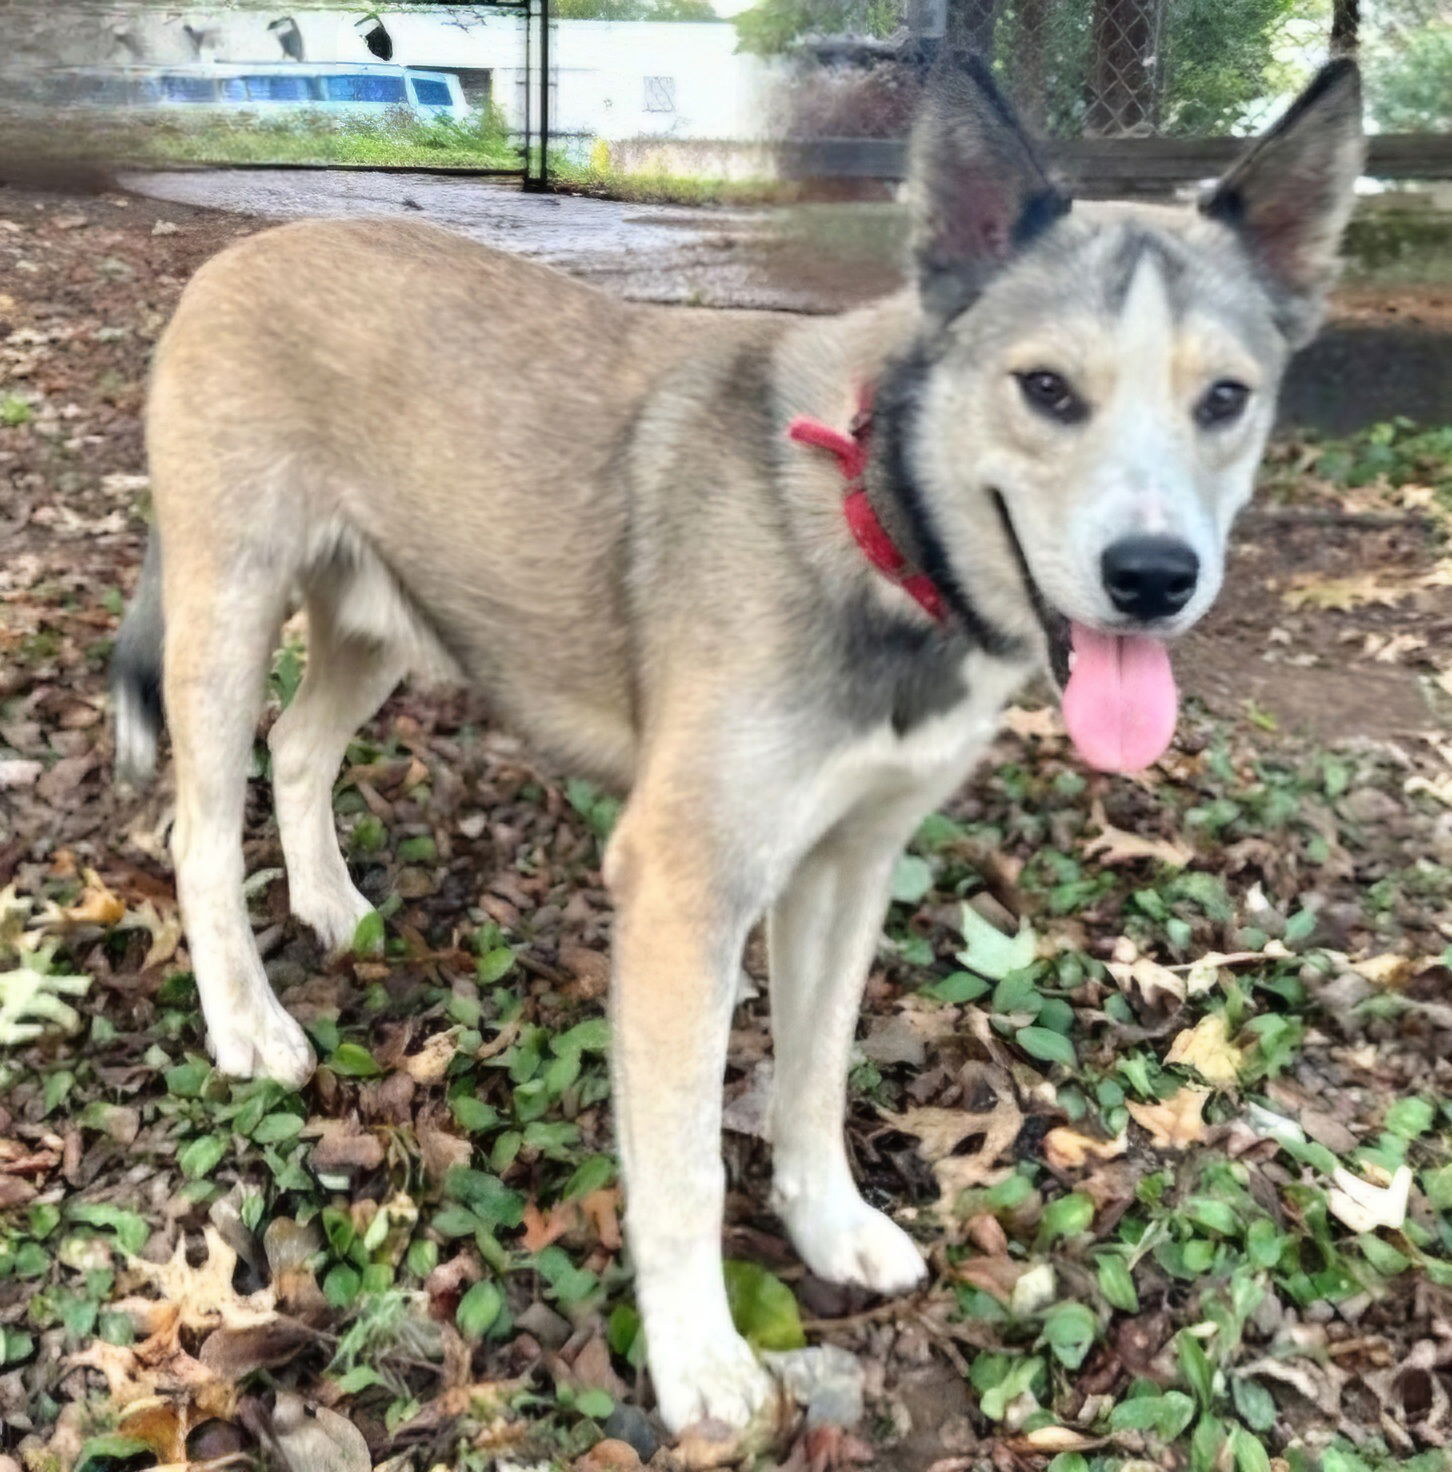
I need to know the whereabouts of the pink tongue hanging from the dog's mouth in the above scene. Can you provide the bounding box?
[1063,624,1180,771]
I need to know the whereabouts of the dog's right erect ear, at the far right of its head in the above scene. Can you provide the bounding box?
[1200,57,1365,347]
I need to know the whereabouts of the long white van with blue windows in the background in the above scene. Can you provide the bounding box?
[35,62,470,118]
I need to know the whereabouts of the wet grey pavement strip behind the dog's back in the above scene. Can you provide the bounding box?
[119,168,860,312]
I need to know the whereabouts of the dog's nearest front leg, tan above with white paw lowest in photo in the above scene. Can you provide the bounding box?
[605,793,773,1431]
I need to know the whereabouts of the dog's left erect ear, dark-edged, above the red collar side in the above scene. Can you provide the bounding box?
[907,54,1069,328]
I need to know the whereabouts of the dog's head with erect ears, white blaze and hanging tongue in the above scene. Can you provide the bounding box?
[888,62,1362,767]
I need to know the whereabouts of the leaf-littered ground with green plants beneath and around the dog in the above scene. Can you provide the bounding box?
[0,191,1452,1472]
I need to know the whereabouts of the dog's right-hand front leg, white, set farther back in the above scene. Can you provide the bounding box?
[767,810,925,1292]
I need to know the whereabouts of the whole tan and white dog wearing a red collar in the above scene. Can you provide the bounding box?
[113,60,1362,1431]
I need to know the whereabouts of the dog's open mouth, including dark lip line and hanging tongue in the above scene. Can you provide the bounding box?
[994,492,1180,771]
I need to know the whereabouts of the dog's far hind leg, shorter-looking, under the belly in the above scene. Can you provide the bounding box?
[268,587,408,951]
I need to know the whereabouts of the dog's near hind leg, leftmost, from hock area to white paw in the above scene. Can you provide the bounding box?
[163,547,312,1086]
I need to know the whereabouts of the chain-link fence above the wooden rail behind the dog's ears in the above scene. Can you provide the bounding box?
[782,0,1452,140]
